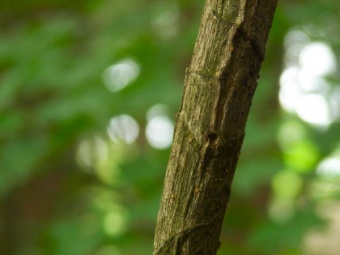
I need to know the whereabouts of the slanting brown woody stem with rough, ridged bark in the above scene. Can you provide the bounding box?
[154,0,277,255]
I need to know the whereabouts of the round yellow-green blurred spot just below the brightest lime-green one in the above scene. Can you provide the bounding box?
[272,170,302,199]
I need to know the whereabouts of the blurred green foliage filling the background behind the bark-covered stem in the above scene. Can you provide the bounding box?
[0,0,340,255]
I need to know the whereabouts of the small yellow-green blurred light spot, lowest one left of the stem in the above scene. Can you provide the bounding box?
[104,206,127,237]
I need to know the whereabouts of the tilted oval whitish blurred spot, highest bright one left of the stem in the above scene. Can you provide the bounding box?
[102,59,140,92]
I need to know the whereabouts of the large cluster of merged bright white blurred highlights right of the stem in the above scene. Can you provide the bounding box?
[279,29,339,129]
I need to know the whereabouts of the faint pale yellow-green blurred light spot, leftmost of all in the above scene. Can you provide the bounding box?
[77,136,108,169]
